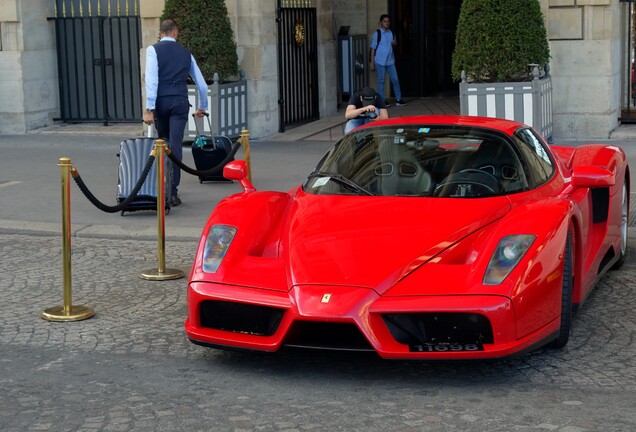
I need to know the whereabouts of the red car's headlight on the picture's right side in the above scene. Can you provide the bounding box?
[483,234,536,285]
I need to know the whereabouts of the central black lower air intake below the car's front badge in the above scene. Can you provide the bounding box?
[284,321,373,351]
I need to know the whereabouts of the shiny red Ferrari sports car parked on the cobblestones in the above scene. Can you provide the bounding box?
[185,116,630,359]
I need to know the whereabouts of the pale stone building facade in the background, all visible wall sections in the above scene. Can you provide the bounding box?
[0,0,629,138]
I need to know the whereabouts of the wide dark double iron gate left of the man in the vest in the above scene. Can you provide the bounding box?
[54,0,142,126]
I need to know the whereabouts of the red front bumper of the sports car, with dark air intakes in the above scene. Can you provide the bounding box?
[185,282,559,359]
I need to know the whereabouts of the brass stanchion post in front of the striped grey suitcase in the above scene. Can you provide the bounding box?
[141,139,185,280]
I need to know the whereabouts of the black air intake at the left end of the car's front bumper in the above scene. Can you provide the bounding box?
[200,300,285,336]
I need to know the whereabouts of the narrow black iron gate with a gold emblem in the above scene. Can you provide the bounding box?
[277,0,320,132]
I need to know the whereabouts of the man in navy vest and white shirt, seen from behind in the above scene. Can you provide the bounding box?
[144,19,208,206]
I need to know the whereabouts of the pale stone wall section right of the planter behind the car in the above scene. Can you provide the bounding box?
[543,0,624,138]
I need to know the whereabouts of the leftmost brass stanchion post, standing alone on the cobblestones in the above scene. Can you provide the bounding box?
[40,157,95,321]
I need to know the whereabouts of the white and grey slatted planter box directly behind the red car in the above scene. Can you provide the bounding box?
[459,69,553,140]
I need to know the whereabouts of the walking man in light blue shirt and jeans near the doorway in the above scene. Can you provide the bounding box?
[369,14,406,106]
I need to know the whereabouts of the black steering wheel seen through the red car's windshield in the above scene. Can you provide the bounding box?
[434,168,501,198]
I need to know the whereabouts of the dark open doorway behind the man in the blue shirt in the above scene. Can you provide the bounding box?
[388,0,462,97]
